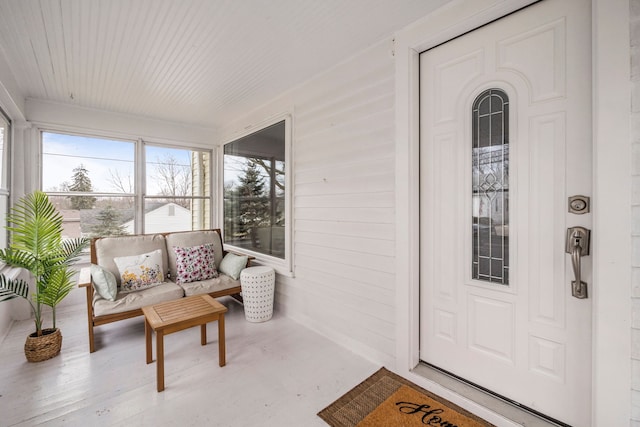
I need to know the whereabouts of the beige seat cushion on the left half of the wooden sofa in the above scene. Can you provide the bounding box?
[93,282,184,316]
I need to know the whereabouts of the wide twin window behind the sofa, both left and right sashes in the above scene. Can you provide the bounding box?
[41,132,211,237]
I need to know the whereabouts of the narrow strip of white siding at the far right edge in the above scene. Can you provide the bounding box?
[629,0,640,426]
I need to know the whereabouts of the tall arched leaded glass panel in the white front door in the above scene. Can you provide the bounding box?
[472,89,509,285]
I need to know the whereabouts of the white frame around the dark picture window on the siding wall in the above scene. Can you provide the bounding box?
[216,113,294,277]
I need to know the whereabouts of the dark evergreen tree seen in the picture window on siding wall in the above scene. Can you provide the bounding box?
[234,159,270,247]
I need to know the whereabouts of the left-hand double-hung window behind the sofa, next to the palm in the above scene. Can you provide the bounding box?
[42,132,135,238]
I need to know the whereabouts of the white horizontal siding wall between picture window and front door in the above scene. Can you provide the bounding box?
[222,41,395,363]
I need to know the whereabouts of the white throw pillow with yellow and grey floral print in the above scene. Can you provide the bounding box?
[113,249,164,292]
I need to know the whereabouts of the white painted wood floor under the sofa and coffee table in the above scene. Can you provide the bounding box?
[0,298,379,427]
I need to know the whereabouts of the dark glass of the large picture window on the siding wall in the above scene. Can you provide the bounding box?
[223,120,290,260]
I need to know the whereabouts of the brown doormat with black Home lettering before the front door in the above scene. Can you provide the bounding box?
[318,368,493,427]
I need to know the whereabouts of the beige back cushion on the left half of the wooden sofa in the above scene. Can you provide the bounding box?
[95,234,169,286]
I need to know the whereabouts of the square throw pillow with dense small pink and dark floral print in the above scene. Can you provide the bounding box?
[173,243,218,284]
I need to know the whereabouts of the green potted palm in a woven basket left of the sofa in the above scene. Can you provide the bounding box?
[0,191,89,362]
